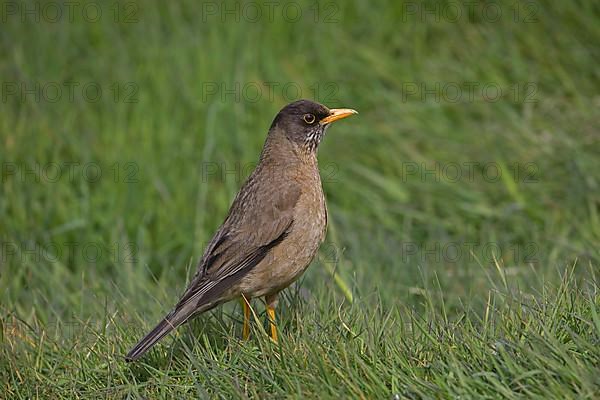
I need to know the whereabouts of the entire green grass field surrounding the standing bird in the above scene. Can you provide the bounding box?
[0,0,600,399]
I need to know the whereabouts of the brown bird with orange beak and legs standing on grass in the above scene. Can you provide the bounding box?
[126,100,357,361]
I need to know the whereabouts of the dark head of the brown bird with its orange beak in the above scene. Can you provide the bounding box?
[271,100,358,152]
